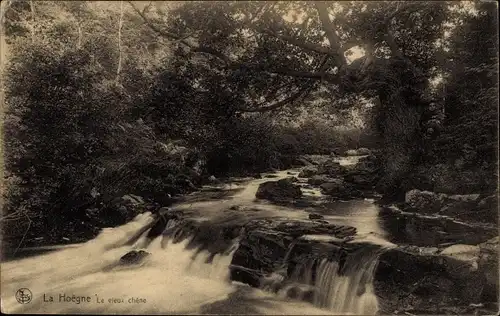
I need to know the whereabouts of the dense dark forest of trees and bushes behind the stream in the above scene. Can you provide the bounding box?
[0,0,498,248]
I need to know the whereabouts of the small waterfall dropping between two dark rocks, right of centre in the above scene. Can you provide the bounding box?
[280,237,390,315]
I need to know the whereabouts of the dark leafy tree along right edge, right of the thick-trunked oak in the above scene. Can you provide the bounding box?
[433,2,498,190]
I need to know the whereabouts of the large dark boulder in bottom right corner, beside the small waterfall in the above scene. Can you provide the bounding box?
[375,245,498,314]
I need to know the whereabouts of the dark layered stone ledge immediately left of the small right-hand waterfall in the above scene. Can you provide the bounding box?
[231,219,356,286]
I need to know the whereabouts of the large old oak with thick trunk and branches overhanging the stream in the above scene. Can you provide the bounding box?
[129,1,449,198]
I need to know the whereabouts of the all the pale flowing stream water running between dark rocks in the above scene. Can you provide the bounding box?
[1,157,434,315]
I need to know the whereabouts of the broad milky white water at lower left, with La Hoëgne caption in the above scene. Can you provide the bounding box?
[1,213,331,315]
